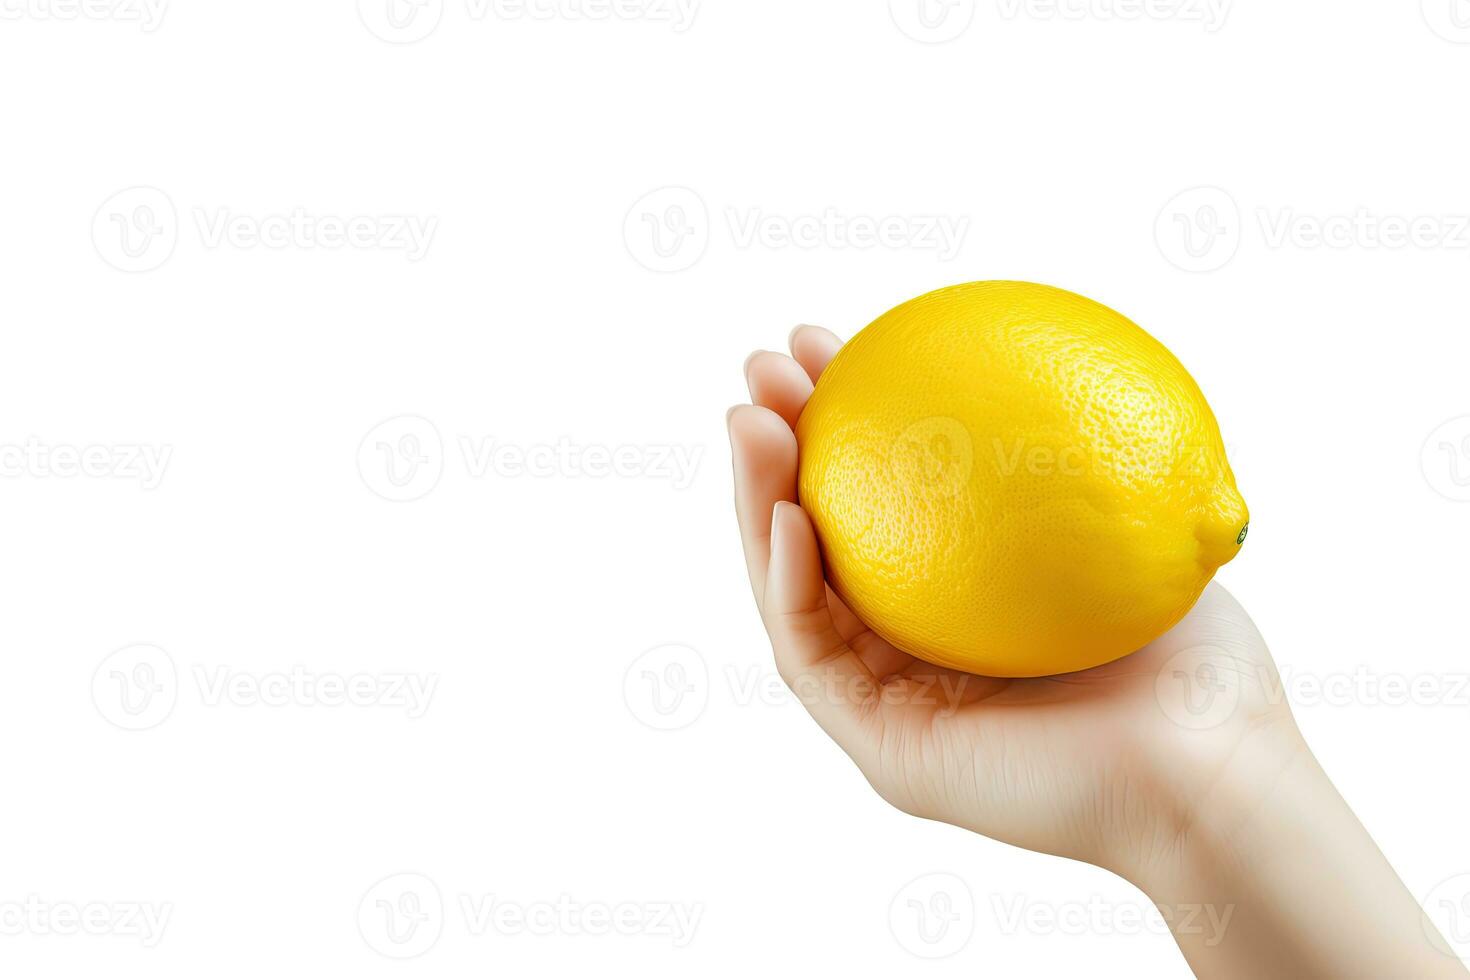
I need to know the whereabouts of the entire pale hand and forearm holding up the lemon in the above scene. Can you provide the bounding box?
[728,326,1470,980]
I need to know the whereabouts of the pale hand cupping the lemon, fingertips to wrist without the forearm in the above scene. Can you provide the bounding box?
[731,328,1285,875]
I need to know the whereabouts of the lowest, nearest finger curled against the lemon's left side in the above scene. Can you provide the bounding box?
[761,502,879,754]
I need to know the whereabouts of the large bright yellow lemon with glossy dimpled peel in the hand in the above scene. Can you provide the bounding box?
[797,282,1250,677]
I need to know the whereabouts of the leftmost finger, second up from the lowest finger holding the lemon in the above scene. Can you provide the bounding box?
[729,406,797,605]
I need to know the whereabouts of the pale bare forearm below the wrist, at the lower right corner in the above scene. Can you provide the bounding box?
[1136,729,1467,980]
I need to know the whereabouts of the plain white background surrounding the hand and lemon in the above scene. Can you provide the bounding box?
[0,0,1470,977]
